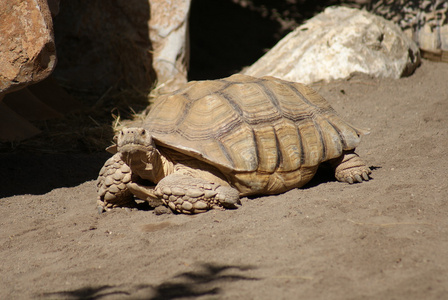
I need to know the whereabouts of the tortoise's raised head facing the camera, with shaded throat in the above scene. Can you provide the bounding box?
[116,127,158,171]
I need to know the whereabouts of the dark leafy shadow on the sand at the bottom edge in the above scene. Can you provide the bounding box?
[41,263,260,300]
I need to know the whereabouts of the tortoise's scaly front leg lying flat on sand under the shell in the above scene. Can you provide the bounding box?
[155,173,241,214]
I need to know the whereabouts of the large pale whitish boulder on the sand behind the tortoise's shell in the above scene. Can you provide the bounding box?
[243,7,420,84]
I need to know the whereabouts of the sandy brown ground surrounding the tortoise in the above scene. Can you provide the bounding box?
[0,61,448,299]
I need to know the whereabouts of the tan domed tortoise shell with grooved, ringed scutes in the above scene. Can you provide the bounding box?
[144,74,364,194]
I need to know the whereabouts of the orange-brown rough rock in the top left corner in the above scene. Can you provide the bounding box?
[0,0,56,95]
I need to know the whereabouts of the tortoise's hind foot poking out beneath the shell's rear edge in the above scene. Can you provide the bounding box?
[330,151,372,183]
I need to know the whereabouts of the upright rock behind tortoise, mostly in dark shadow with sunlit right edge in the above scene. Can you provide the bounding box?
[55,0,190,95]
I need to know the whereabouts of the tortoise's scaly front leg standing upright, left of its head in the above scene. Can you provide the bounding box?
[97,153,135,212]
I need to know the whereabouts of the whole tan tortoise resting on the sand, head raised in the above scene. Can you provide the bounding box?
[97,74,371,214]
